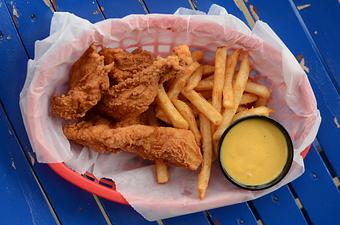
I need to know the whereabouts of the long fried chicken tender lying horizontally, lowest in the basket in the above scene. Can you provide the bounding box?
[63,121,202,170]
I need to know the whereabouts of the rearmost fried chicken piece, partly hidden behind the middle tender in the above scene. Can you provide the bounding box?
[99,48,155,84]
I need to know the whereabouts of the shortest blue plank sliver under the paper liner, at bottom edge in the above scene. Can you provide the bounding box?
[163,212,210,225]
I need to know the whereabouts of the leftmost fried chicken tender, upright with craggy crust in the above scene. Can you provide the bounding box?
[51,44,113,120]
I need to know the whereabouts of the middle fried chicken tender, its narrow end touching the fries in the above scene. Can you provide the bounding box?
[97,56,182,120]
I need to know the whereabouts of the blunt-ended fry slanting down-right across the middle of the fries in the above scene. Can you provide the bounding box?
[182,90,223,125]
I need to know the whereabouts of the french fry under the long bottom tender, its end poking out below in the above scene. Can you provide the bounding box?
[147,107,169,184]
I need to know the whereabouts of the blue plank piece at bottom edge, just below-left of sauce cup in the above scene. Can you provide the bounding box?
[209,203,257,225]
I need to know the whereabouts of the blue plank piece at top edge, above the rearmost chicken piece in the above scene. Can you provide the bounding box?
[98,0,146,18]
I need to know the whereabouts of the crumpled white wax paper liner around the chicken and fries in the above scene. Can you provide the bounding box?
[20,5,321,220]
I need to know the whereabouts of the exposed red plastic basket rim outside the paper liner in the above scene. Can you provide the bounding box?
[48,146,311,205]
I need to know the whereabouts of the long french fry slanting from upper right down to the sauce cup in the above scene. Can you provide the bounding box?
[213,53,250,140]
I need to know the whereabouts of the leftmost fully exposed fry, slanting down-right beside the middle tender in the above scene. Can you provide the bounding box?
[157,85,189,129]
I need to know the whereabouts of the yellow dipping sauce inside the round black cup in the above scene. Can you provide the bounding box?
[220,118,288,186]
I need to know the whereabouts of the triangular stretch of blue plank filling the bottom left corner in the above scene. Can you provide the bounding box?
[0,105,56,225]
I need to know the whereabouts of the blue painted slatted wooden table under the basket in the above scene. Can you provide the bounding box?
[0,0,340,225]
